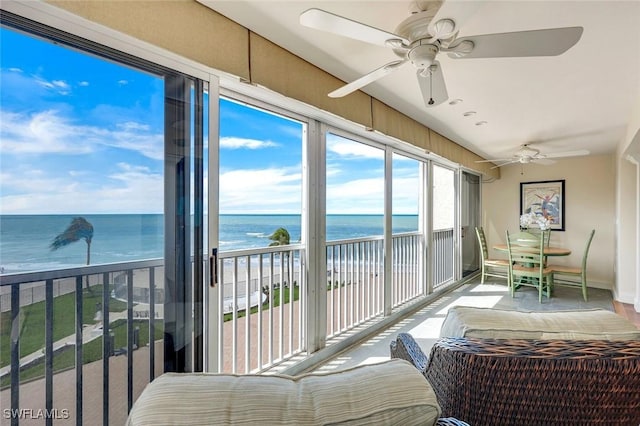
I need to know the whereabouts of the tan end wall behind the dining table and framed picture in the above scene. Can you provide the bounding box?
[482,155,616,289]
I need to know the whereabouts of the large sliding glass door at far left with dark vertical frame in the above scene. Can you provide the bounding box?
[0,15,208,424]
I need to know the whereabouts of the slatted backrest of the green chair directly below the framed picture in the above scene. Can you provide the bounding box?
[506,231,544,277]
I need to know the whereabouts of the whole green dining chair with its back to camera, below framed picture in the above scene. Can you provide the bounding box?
[506,231,553,303]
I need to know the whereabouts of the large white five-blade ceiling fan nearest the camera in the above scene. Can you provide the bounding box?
[300,0,582,107]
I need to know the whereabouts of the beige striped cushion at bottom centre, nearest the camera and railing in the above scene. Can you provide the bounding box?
[127,359,440,426]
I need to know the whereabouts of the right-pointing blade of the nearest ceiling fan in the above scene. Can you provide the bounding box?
[449,27,583,58]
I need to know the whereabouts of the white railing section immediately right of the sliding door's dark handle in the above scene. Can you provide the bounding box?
[218,245,306,373]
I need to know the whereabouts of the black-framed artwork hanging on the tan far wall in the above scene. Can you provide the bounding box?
[520,179,565,231]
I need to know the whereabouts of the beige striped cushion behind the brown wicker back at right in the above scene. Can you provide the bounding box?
[440,306,640,340]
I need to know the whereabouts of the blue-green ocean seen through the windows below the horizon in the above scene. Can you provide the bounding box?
[0,214,418,273]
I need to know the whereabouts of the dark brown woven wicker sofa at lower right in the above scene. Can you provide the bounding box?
[391,310,640,426]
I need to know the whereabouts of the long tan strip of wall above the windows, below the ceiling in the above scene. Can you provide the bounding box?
[47,0,500,178]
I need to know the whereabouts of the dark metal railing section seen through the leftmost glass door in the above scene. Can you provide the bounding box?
[0,260,164,425]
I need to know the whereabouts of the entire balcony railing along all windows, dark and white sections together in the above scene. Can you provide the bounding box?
[0,229,453,425]
